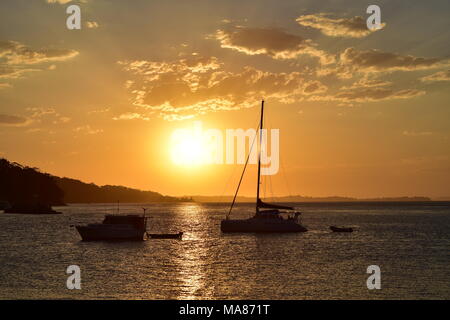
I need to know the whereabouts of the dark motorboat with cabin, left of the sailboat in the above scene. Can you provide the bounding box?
[76,213,147,241]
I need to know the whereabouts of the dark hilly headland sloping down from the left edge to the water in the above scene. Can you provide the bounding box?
[0,158,192,212]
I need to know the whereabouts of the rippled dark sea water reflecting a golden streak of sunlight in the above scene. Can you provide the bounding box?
[0,202,450,299]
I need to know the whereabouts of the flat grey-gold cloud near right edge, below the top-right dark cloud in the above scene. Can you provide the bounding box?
[340,48,442,72]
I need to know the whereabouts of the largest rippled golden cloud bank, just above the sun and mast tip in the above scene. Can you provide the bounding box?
[116,56,327,120]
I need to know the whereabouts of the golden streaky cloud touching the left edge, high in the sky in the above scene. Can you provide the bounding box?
[0,40,79,65]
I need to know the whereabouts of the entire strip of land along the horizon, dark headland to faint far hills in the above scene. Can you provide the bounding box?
[0,158,440,211]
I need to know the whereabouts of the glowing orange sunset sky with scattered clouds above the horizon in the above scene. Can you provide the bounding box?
[0,0,450,197]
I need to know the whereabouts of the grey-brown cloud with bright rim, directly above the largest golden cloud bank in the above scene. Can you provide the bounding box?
[212,26,335,64]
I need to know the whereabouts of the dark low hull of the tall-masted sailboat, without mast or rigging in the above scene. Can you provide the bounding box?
[220,218,308,233]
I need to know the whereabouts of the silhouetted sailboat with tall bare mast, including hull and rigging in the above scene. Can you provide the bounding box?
[220,100,308,233]
